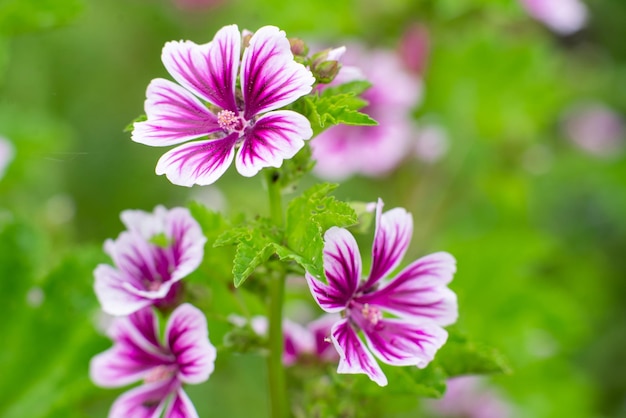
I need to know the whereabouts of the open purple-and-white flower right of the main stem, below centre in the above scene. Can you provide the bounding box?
[306,200,458,386]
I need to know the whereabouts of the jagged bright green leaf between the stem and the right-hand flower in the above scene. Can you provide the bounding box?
[284,183,357,277]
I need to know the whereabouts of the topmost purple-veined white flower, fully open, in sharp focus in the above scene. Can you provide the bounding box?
[132,25,315,186]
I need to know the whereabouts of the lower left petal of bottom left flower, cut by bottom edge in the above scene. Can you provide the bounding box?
[109,380,172,418]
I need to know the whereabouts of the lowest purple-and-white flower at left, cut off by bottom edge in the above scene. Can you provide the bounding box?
[90,304,216,418]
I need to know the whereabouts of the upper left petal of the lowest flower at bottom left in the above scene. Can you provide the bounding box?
[89,308,174,387]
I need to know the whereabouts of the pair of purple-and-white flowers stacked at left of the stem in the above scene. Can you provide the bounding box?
[90,206,216,418]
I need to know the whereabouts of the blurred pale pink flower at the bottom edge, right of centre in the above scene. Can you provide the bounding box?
[427,376,512,418]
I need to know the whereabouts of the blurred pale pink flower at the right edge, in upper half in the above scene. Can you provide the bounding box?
[562,103,626,157]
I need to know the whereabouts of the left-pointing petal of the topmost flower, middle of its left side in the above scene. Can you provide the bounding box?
[131,78,221,147]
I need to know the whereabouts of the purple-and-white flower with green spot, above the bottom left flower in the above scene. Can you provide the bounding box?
[94,206,206,315]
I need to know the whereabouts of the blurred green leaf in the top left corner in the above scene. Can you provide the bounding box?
[0,0,83,35]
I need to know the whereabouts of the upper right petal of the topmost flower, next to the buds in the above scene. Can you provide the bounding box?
[241,26,315,120]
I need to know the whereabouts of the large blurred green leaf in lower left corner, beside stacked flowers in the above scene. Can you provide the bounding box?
[0,225,104,418]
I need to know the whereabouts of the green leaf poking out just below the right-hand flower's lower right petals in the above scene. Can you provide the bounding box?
[435,331,511,377]
